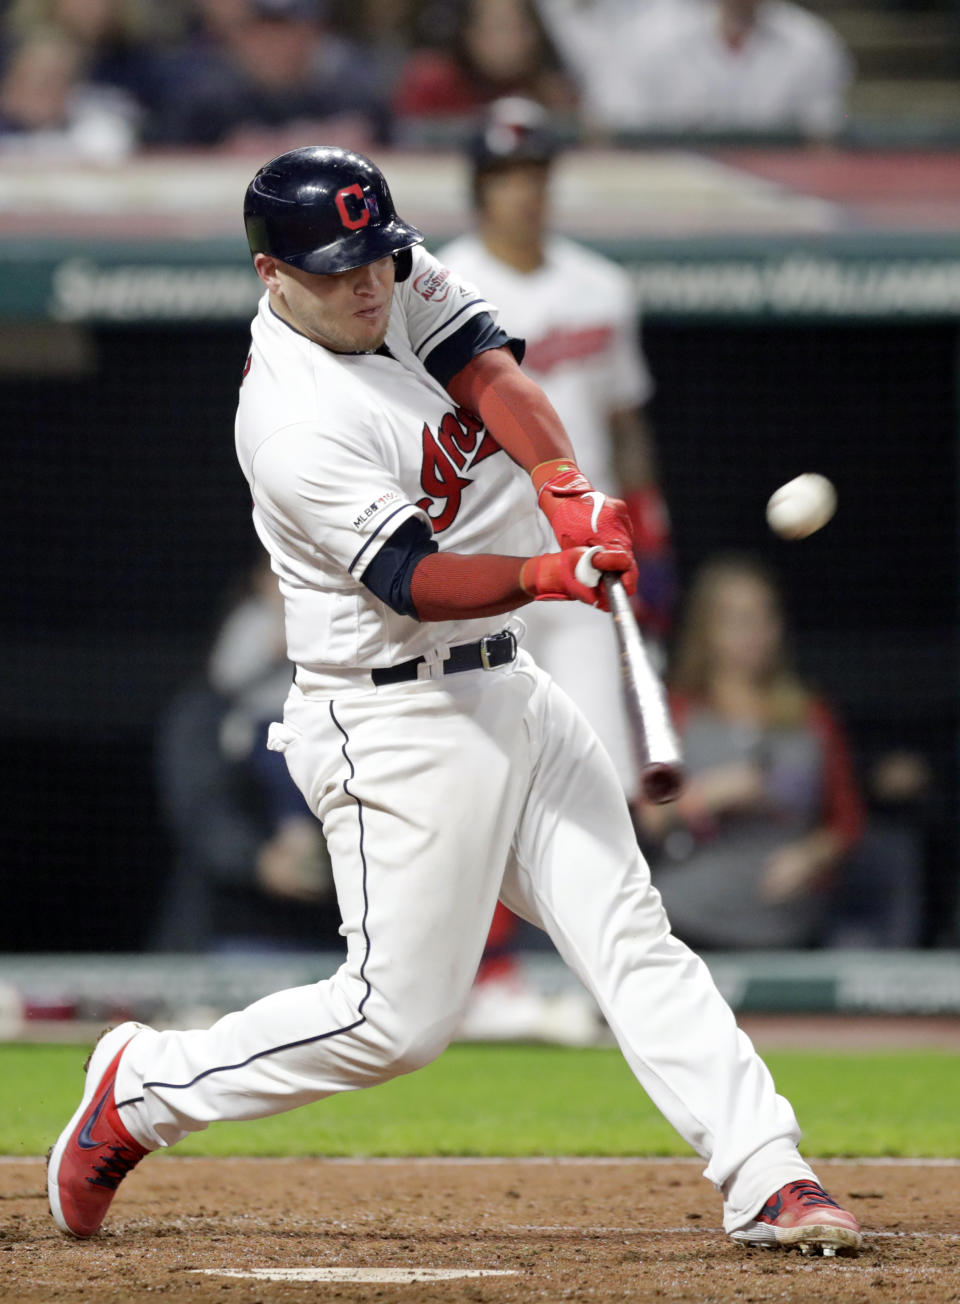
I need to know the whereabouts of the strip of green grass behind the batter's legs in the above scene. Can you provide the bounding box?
[0,1045,960,1157]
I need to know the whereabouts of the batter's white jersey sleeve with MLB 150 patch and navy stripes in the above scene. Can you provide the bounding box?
[252,424,430,587]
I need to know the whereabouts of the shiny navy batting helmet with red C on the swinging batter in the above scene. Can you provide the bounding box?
[244,145,424,280]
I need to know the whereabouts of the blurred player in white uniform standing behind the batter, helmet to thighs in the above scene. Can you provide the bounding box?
[438,98,673,801]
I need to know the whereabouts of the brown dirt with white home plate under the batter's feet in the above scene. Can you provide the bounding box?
[0,1155,960,1304]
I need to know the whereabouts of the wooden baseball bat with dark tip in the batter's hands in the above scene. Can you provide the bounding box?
[604,575,683,803]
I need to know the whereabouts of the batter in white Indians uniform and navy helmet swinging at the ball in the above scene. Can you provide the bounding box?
[48,147,860,1251]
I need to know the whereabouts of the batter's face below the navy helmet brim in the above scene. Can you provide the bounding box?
[254,254,394,353]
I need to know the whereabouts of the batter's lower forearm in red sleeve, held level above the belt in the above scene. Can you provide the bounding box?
[410,553,532,621]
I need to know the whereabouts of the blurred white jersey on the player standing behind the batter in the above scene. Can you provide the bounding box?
[438,235,653,492]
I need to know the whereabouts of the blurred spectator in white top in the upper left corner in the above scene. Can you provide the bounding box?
[0,30,138,163]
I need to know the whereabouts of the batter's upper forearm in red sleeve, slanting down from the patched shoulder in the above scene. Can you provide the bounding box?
[447,348,574,471]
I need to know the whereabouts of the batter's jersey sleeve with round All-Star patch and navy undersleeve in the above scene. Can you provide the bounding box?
[398,246,524,386]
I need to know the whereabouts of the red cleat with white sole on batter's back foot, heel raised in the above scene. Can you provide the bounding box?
[47,1024,149,1236]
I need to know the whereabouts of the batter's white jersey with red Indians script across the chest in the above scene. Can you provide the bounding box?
[236,248,552,686]
